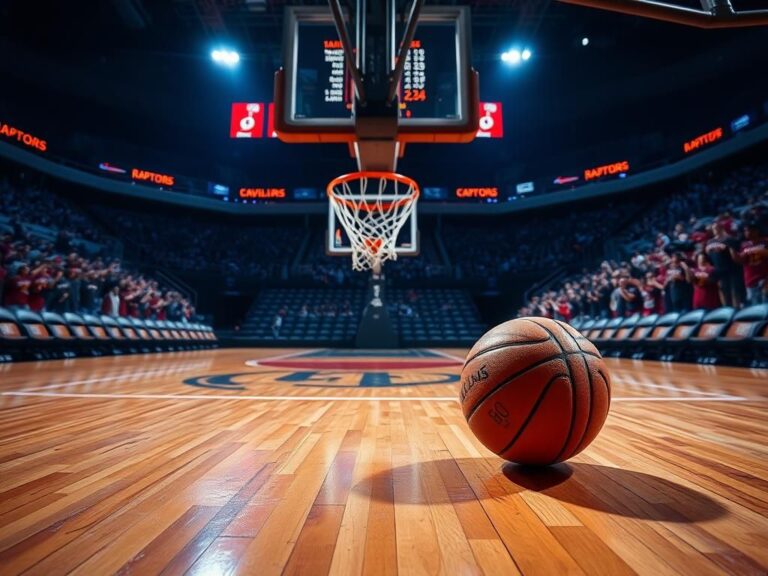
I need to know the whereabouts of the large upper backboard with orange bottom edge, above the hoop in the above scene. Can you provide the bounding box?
[275,6,479,170]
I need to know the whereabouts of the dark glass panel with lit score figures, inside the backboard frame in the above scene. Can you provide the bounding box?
[284,8,470,126]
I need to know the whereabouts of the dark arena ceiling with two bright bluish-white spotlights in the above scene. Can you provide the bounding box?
[0,0,768,188]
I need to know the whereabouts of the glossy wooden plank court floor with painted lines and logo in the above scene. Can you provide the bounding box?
[0,350,768,576]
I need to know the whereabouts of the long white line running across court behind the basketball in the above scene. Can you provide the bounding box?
[0,392,748,402]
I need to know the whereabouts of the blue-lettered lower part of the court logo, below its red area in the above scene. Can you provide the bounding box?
[184,370,459,391]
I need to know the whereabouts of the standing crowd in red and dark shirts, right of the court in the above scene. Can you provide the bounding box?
[519,167,768,321]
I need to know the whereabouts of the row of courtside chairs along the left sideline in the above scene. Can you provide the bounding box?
[0,307,218,362]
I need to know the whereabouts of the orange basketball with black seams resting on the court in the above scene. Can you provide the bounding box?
[461,318,611,464]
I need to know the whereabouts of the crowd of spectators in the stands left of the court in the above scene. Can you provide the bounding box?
[0,173,195,321]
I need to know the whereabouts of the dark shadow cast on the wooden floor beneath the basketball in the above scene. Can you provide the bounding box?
[360,458,727,523]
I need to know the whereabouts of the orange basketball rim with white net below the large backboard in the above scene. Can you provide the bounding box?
[328,172,419,274]
